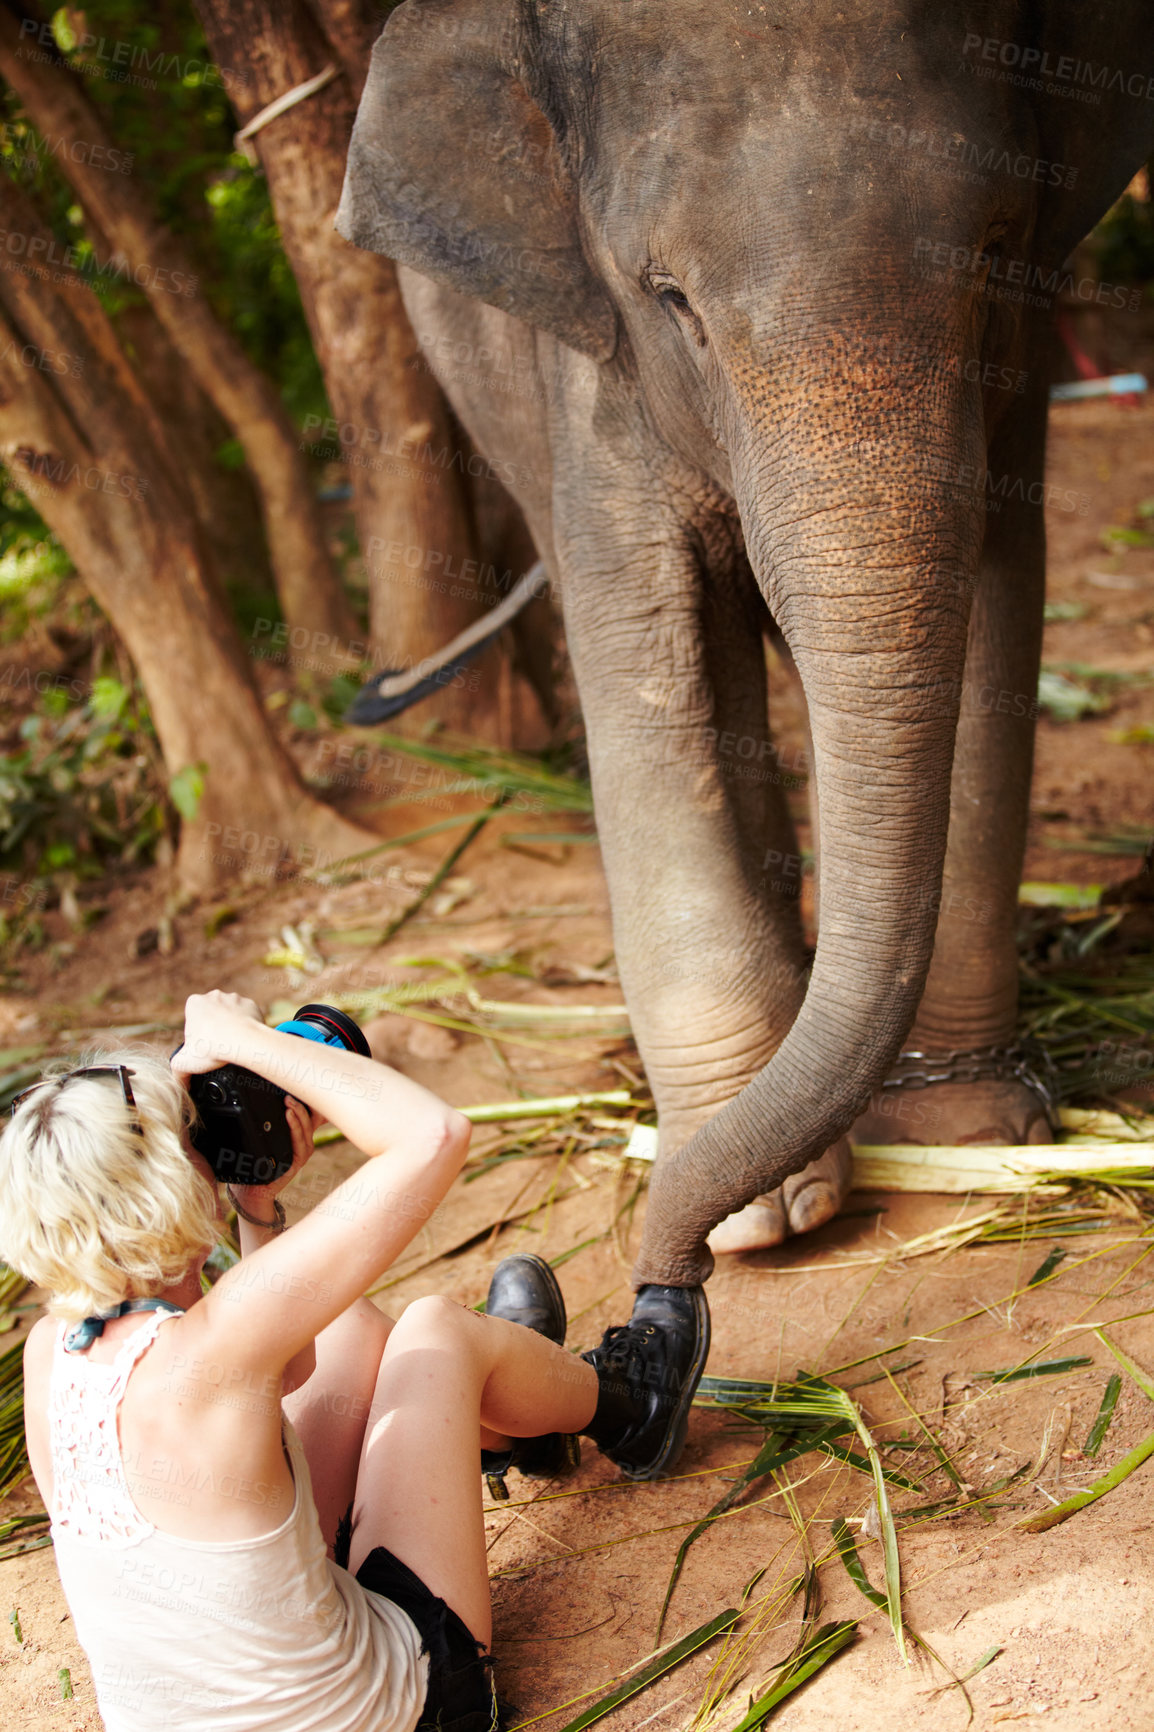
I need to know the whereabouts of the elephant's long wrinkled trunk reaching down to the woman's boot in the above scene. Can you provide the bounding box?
[634,361,984,1285]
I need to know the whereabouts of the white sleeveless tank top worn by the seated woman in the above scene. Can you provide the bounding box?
[50,1313,428,1732]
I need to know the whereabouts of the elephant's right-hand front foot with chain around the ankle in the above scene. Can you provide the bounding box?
[849,1077,1052,1147]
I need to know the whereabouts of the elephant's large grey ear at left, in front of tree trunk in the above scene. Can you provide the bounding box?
[336,0,617,360]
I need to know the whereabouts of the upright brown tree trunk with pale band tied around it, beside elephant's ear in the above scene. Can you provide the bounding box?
[196,0,530,740]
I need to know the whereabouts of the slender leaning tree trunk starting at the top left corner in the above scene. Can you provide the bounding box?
[0,0,357,639]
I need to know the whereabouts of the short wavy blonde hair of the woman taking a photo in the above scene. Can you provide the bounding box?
[0,1051,218,1323]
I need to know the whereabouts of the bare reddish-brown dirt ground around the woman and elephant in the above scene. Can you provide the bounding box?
[0,404,1154,1732]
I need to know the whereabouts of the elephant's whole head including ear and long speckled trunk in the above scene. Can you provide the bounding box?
[338,0,1154,1278]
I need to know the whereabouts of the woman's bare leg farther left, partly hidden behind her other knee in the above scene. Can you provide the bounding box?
[281,1299,395,1557]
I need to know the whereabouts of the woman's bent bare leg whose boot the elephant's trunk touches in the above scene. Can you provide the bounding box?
[348,1299,598,1647]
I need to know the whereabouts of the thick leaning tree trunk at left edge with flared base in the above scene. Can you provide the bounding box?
[0,175,373,892]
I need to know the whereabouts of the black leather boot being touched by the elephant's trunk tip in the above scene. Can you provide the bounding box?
[582,1285,709,1479]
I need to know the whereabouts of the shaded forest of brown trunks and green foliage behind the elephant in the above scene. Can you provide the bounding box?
[0,0,1154,937]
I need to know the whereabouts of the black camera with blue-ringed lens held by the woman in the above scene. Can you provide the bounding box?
[189,1005,371,1185]
